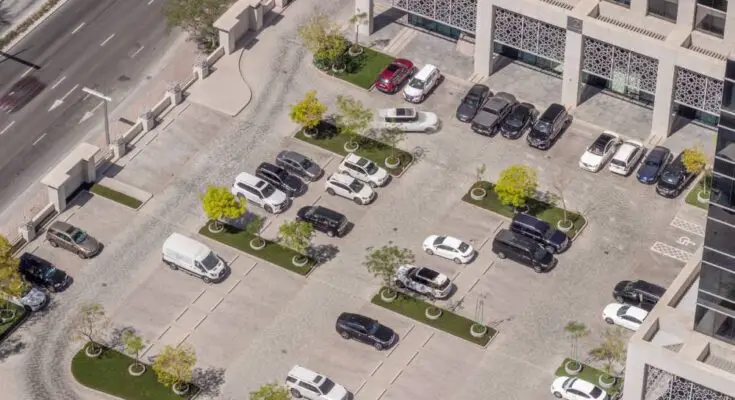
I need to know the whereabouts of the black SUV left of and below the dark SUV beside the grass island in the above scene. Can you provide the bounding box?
[493,229,556,273]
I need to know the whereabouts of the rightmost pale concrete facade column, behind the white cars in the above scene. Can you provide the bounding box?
[651,59,676,139]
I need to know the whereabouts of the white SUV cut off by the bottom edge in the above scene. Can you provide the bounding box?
[286,365,352,400]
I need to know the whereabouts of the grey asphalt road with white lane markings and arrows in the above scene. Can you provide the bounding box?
[0,0,177,210]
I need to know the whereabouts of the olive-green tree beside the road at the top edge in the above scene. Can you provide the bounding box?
[163,0,234,51]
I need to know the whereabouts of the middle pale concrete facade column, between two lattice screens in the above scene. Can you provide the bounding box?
[561,16,584,110]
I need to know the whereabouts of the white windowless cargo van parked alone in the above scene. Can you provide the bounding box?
[162,233,227,283]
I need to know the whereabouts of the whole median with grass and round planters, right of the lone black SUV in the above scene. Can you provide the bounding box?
[372,287,497,347]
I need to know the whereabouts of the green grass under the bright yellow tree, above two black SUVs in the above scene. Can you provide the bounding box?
[462,181,587,238]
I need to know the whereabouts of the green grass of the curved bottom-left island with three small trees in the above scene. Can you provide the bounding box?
[71,348,199,400]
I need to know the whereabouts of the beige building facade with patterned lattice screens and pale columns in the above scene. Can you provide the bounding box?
[355,0,735,141]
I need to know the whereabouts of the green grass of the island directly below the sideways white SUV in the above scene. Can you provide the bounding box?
[296,130,413,176]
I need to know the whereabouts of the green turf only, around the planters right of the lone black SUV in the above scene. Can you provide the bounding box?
[372,288,497,346]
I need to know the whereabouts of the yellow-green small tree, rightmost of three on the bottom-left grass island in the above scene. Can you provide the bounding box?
[152,344,197,393]
